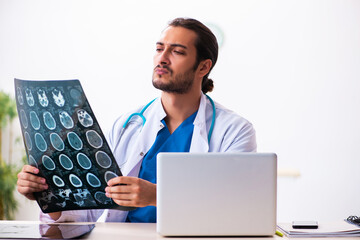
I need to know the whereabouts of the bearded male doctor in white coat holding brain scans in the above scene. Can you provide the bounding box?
[17,18,256,222]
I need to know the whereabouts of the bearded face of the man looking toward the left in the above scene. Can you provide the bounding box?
[153,27,197,94]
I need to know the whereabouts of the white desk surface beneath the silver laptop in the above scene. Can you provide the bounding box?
[0,221,360,240]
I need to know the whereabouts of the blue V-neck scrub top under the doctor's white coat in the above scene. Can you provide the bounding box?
[126,111,197,223]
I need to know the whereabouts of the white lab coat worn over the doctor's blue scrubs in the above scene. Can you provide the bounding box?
[40,94,256,222]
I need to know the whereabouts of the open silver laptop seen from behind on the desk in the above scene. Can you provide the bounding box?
[157,153,277,236]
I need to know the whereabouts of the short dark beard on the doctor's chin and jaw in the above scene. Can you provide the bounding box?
[152,66,195,94]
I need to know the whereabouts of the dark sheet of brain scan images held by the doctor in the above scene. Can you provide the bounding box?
[15,79,131,213]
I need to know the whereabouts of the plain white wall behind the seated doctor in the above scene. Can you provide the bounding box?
[0,0,360,221]
